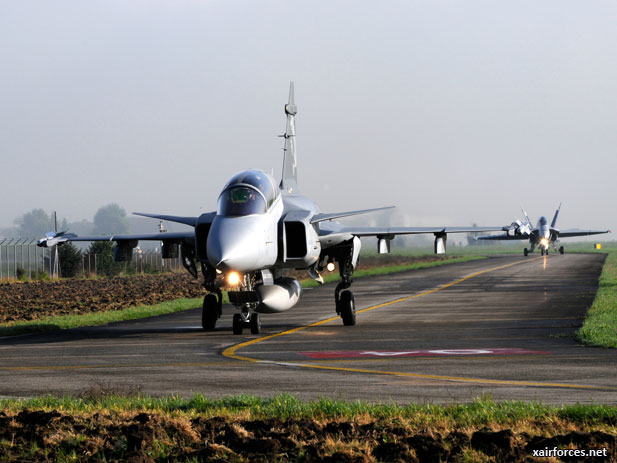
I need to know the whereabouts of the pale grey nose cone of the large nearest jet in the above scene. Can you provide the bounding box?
[207,217,264,272]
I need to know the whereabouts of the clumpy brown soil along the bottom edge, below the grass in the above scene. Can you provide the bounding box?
[0,410,616,463]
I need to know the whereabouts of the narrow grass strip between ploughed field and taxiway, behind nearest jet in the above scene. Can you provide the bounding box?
[0,256,483,336]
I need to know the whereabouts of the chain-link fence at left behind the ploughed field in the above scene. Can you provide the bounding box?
[0,238,182,280]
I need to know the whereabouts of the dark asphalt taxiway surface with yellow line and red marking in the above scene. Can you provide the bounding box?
[0,254,617,404]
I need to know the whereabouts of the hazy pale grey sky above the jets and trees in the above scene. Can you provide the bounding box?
[0,0,617,238]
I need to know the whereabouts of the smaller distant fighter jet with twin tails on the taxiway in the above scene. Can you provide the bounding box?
[476,204,610,256]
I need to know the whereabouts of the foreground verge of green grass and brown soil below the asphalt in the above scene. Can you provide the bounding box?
[0,395,617,463]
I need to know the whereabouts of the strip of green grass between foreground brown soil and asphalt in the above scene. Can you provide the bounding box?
[0,394,617,428]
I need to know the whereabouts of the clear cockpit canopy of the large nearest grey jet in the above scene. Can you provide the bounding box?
[217,170,280,216]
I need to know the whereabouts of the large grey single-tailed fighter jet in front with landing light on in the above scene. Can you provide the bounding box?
[38,82,502,334]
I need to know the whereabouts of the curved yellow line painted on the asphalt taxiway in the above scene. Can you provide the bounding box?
[223,257,617,390]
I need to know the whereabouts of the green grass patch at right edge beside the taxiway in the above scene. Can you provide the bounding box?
[577,247,617,348]
